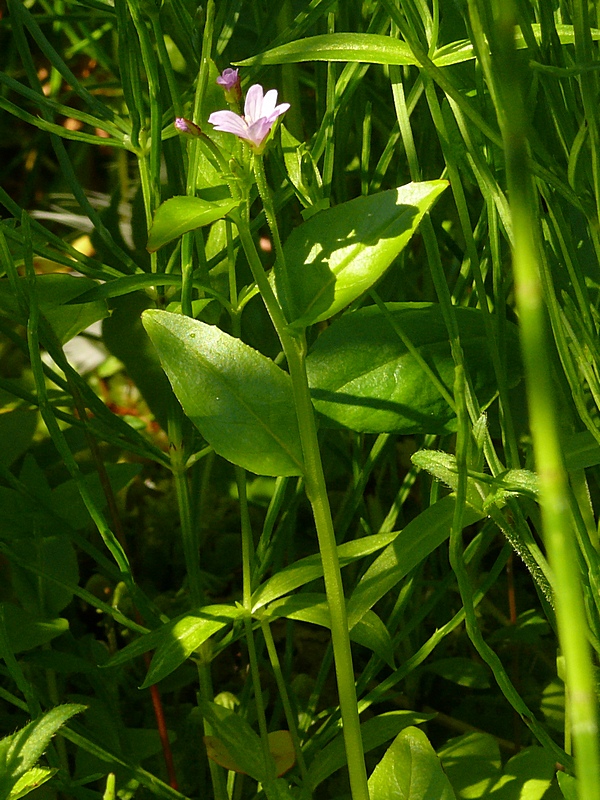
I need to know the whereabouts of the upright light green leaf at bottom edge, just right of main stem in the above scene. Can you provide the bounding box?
[369,727,456,800]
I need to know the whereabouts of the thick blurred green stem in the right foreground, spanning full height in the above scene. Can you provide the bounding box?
[493,2,600,800]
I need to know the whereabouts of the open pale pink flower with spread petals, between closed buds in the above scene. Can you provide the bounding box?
[208,83,290,153]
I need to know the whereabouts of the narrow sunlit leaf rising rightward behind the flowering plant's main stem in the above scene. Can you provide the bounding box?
[252,532,398,613]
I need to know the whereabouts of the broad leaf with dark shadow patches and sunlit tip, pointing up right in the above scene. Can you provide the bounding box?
[275,181,448,328]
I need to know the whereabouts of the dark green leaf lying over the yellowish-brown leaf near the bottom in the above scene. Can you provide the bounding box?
[198,701,275,783]
